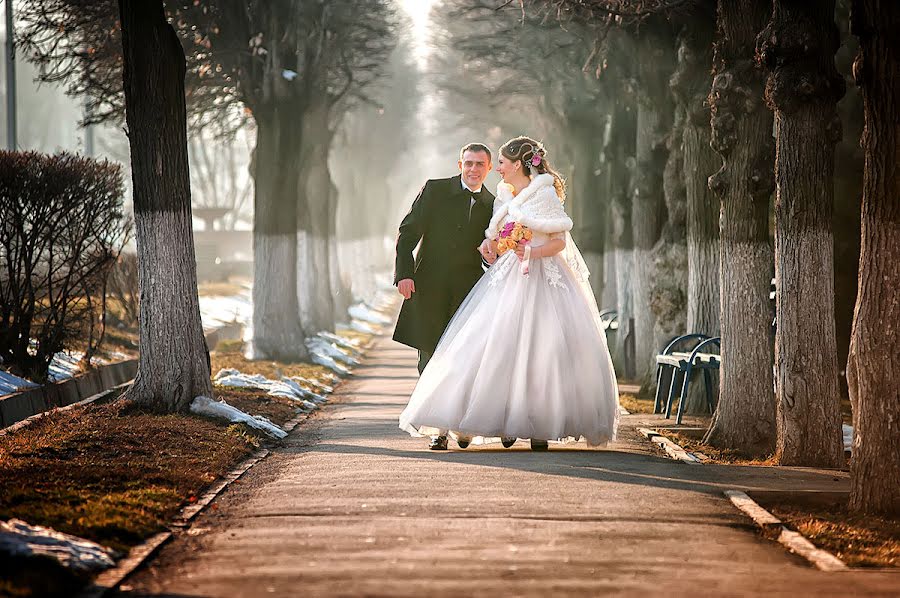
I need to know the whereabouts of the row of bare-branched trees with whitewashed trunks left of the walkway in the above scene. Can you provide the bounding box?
[17,0,397,410]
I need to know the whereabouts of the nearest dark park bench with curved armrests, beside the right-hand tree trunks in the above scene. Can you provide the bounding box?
[653,333,722,425]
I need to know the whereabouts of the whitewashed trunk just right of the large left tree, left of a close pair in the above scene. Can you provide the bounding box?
[250,110,308,361]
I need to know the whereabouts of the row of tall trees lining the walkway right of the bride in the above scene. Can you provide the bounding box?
[441,0,900,512]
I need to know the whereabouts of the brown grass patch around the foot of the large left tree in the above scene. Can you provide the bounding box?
[0,404,256,552]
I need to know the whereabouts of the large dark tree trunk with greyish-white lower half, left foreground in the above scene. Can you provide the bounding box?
[119,0,212,413]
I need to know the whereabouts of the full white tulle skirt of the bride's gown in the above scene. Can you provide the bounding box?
[400,252,618,446]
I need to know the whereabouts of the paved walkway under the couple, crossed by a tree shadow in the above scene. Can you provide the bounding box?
[128,339,900,596]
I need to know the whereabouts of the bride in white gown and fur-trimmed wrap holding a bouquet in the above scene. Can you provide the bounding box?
[400,137,618,450]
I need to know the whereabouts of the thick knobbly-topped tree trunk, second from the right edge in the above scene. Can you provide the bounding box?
[758,0,845,467]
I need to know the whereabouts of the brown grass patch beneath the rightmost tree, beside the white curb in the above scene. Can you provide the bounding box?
[765,499,900,567]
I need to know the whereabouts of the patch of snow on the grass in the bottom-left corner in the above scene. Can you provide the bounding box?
[0,519,116,573]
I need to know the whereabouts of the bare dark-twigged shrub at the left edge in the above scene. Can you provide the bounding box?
[0,151,130,381]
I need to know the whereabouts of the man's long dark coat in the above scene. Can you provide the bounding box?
[394,176,494,354]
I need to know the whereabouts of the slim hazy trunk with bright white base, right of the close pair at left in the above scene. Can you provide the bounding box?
[297,102,334,332]
